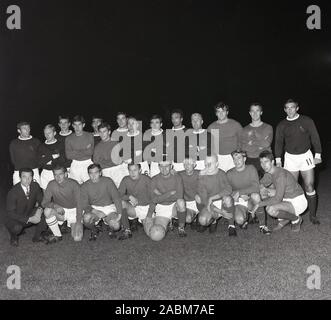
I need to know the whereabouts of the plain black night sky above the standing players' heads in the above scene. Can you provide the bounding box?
[0,0,331,169]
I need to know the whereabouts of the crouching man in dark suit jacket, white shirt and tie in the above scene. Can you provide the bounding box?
[4,168,47,247]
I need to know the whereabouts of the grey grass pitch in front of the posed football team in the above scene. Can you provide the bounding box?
[0,160,331,300]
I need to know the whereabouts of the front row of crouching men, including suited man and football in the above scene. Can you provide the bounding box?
[5,150,307,246]
